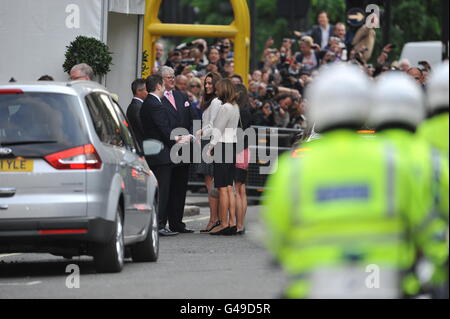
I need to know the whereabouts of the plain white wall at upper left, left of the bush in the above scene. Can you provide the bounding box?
[0,0,103,82]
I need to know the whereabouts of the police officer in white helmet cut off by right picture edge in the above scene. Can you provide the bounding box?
[419,61,449,158]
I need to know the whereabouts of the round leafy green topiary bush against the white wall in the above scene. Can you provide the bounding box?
[63,36,112,76]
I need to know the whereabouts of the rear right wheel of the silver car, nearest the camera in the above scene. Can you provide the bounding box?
[94,206,125,273]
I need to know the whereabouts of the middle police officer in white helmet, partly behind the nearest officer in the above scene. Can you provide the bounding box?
[369,72,449,297]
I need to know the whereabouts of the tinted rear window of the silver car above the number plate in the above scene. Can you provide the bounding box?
[0,93,88,157]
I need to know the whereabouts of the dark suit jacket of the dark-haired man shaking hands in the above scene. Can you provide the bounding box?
[141,94,177,166]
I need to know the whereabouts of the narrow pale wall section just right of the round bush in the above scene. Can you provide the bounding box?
[106,12,140,111]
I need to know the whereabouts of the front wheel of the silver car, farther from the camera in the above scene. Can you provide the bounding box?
[131,205,159,262]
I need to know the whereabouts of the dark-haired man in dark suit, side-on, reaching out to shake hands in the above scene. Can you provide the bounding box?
[140,75,178,236]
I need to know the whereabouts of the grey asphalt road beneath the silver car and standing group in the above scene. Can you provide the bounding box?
[0,202,284,299]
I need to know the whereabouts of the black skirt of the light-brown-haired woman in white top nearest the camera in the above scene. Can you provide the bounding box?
[214,143,236,188]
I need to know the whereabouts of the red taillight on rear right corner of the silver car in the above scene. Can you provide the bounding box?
[44,144,102,169]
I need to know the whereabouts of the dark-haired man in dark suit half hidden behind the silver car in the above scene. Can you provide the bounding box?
[127,79,148,146]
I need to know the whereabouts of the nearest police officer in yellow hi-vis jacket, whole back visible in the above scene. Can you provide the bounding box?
[262,65,428,298]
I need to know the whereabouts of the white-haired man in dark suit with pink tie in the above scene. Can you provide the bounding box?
[161,66,196,233]
